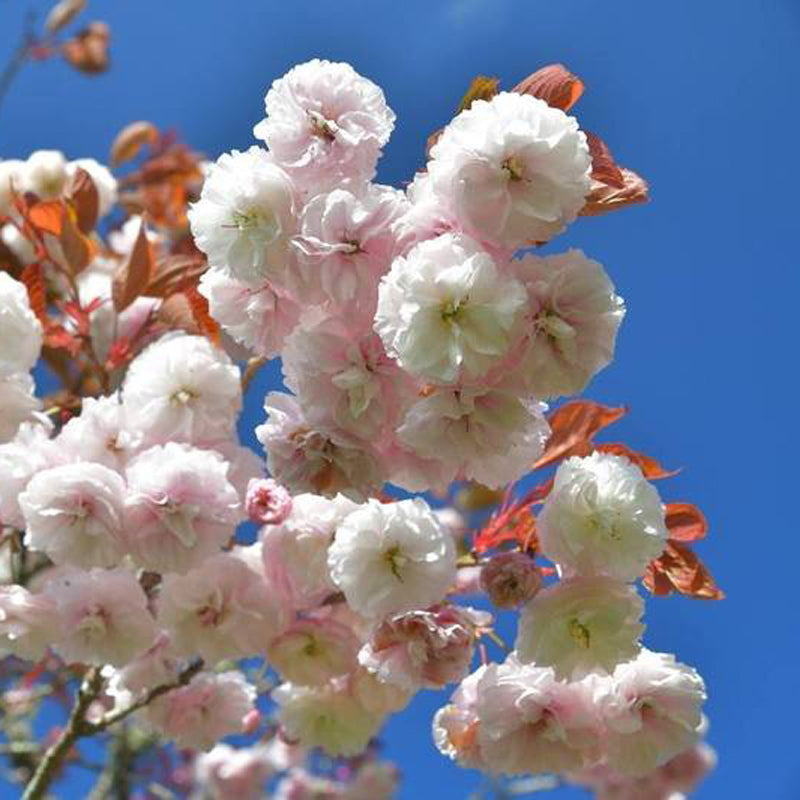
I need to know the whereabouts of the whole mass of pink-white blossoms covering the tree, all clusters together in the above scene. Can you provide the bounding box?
[0,60,710,800]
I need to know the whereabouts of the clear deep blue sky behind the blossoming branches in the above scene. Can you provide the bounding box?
[0,0,800,800]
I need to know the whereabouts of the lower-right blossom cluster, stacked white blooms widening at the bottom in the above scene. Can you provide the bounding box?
[434,453,705,797]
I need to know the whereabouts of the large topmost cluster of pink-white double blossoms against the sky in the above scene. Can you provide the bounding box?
[190,60,624,500]
